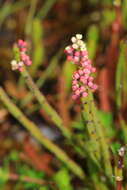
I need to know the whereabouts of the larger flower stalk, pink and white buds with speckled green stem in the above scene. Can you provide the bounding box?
[65,34,112,176]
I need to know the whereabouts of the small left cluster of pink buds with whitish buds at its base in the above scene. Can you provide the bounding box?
[11,40,32,72]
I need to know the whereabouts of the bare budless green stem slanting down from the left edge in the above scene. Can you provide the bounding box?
[0,87,85,178]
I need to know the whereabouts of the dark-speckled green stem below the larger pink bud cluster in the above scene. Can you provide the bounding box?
[82,89,112,176]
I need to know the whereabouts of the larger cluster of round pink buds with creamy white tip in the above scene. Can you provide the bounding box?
[65,34,98,100]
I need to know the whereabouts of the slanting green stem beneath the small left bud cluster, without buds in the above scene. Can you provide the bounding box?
[21,68,71,138]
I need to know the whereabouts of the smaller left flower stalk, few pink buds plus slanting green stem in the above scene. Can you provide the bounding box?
[11,40,71,139]
